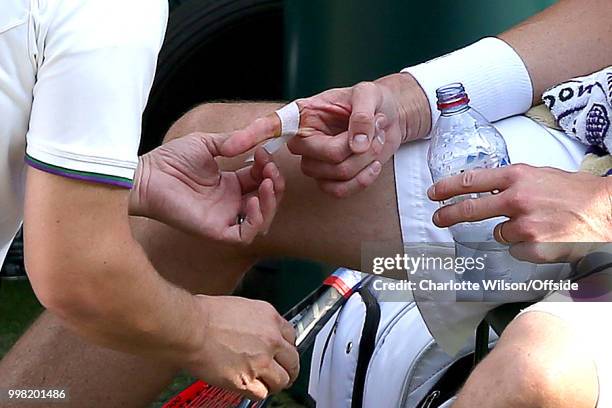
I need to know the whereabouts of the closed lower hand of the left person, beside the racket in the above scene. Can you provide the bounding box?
[188,296,300,400]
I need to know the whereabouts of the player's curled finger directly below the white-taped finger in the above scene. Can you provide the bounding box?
[287,132,353,163]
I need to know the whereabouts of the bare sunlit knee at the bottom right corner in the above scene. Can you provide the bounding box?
[453,312,598,408]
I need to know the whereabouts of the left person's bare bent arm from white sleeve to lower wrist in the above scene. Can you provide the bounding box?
[24,168,203,370]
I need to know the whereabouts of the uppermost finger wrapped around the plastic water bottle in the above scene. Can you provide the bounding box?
[427,167,514,201]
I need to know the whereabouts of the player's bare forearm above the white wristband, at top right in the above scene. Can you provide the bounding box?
[499,0,612,103]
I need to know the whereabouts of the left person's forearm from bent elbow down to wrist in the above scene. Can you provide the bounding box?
[48,241,204,368]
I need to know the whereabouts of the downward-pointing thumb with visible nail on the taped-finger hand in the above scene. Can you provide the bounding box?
[348,82,382,153]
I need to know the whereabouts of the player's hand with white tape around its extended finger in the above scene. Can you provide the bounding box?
[221,74,431,197]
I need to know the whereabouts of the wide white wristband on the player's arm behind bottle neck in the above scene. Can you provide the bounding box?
[402,37,533,131]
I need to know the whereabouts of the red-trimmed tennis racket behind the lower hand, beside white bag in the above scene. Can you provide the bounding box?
[163,269,367,408]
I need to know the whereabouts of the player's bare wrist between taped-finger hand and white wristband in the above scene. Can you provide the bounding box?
[375,73,432,143]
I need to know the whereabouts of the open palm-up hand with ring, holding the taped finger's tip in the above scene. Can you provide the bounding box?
[129,133,285,244]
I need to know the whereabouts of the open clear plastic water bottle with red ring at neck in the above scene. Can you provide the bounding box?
[428,83,512,300]
